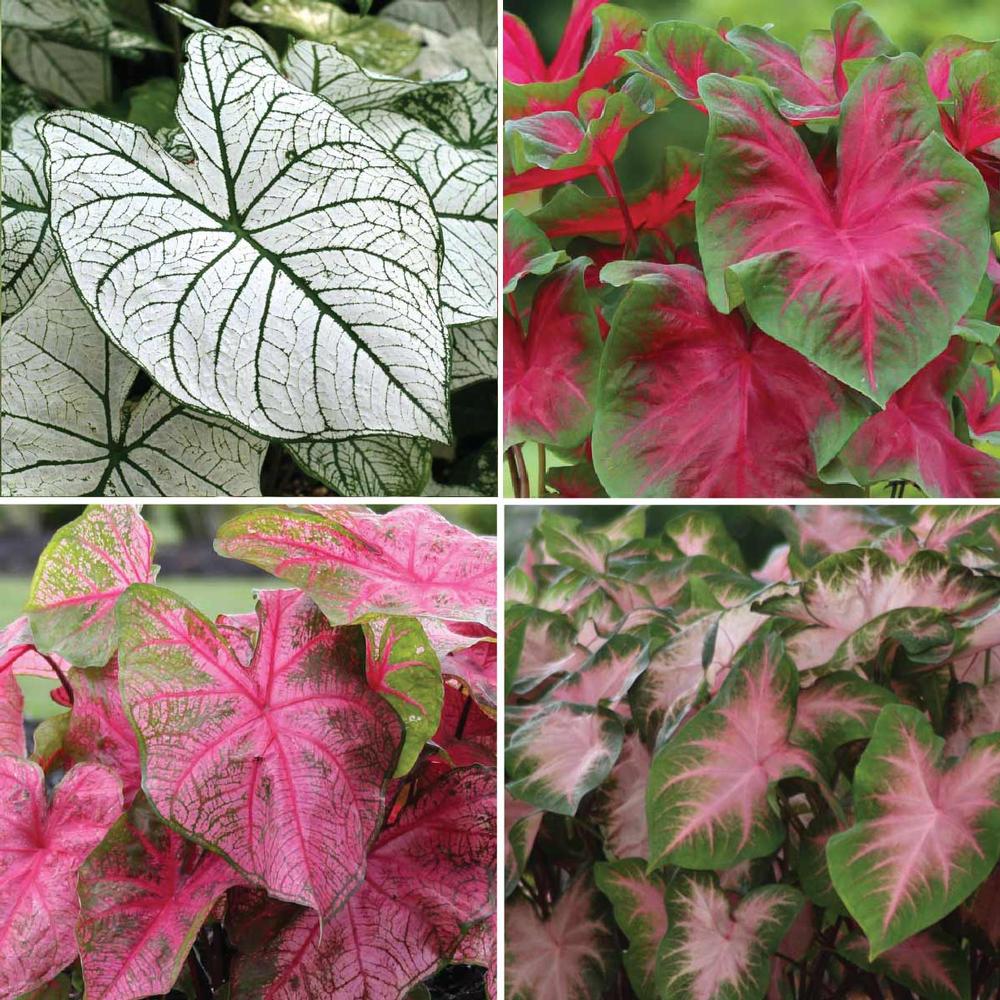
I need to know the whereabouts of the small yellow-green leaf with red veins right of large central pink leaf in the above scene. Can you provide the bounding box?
[364,618,444,777]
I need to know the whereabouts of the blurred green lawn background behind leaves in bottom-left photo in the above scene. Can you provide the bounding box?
[0,504,496,720]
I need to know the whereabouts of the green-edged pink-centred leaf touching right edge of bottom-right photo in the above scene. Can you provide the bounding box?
[826,705,1000,959]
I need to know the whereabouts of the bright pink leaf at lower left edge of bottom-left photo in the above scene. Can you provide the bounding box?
[0,754,122,997]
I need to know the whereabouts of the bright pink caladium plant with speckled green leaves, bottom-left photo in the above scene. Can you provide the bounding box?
[0,505,497,1000]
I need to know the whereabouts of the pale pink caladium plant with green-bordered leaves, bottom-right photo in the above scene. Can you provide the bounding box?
[505,506,1000,1000]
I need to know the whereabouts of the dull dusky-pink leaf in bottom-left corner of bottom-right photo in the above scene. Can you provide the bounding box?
[504,872,618,1000]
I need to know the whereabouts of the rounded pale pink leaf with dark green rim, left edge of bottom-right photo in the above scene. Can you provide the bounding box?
[506,703,624,816]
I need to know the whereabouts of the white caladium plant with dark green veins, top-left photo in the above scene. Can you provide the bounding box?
[0,0,497,496]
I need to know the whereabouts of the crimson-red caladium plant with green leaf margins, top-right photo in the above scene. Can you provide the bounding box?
[503,2,1000,497]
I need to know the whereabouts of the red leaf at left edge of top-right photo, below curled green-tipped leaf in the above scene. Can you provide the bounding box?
[503,257,602,448]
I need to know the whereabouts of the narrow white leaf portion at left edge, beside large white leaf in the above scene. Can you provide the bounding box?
[0,114,59,317]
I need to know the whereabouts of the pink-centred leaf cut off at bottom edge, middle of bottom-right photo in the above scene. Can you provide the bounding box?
[656,875,803,1000]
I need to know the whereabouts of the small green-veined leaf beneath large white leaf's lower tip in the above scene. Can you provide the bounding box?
[288,434,431,497]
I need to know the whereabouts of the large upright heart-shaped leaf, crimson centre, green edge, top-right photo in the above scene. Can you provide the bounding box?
[696,55,989,405]
